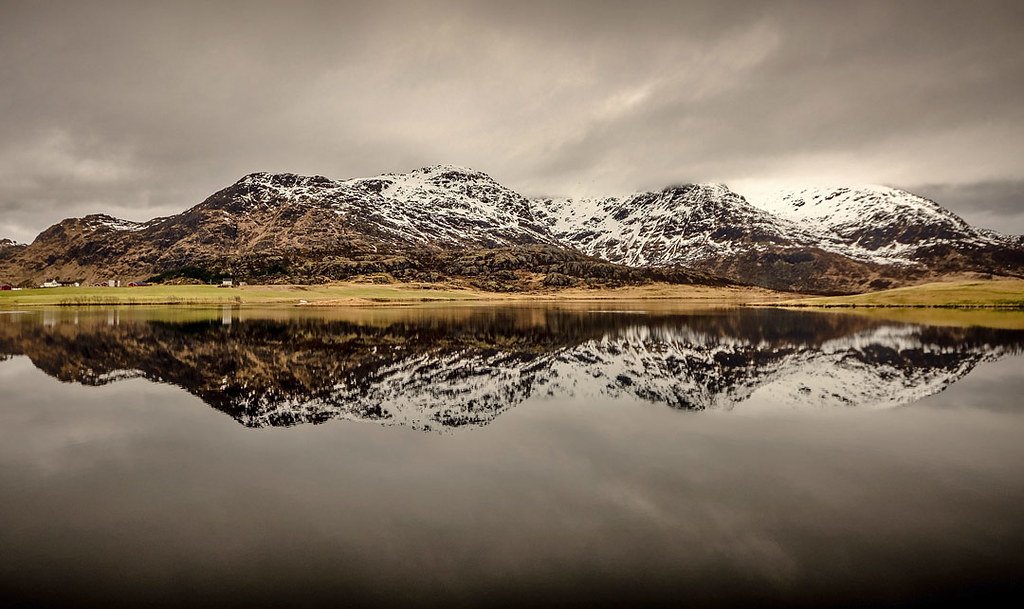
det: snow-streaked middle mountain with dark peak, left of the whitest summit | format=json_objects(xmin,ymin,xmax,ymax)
[{"xmin": 534, "ymin": 184, "xmax": 890, "ymax": 293}]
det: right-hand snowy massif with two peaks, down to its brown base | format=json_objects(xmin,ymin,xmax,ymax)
[{"xmin": 532, "ymin": 184, "xmax": 1024, "ymax": 293}]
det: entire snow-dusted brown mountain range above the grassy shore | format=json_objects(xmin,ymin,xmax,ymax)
[{"xmin": 0, "ymin": 165, "xmax": 1024, "ymax": 294}]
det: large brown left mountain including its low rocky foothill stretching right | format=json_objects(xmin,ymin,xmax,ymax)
[{"xmin": 0, "ymin": 165, "xmax": 725, "ymax": 291}]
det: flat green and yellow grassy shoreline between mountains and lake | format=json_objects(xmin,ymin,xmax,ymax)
[{"xmin": 6, "ymin": 279, "xmax": 1024, "ymax": 311}]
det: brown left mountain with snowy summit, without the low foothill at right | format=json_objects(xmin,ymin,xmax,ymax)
[{"xmin": 9, "ymin": 166, "xmax": 557, "ymax": 279}]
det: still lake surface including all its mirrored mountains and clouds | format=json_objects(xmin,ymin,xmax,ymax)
[{"xmin": 0, "ymin": 306, "xmax": 1024, "ymax": 607}]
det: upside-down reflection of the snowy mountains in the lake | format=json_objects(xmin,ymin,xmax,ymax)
[{"xmin": 0, "ymin": 307, "xmax": 1024, "ymax": 430}]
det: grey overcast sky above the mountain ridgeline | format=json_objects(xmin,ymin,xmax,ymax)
[{"xmin": 0, "ymin": 0, "xmax": 1024, "ymax": 242}]
